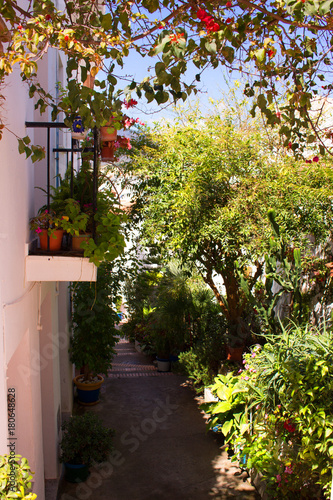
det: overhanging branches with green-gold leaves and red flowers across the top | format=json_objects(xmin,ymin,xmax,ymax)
[{"xmin": 0, "ymin": 0, "xmax": 333, "ymax": 152}]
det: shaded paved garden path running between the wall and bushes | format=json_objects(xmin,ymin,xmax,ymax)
[{"xmin": 58, "ymin": 340, "xmax": 260, "ymax": 500}]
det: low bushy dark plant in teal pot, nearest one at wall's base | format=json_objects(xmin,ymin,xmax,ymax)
[{"xmin": 60, "ymin": 412, "xmax": 114, "ymax": 483}]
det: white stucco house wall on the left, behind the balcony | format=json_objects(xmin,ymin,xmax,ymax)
[{"xmin": 0, "ymin": 41, "xmax": 72, "ymax": 500}]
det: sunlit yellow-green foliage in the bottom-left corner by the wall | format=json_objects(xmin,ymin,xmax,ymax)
[{"xmin": 0, "ymin": 455, "xmax": 37, "ymax": 500}]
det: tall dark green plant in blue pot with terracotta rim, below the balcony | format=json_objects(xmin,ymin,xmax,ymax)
[{"xmin": 70, "ymin": 262, "xmax": 119, "ymax": 405}]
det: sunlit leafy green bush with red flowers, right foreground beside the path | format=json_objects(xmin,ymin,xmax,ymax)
[{"xmin": 204, "ymin": 326, "xmax": 333, "ymax": 499}]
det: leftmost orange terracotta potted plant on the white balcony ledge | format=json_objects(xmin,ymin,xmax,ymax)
[{"xmin": 30, "ymin": 205, "xmax": 64, "ymax": 251}]
